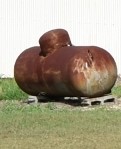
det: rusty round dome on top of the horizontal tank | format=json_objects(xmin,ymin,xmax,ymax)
[{"xmin": 39, "ymin": 29, "xmax": 72, "ymax": 56}]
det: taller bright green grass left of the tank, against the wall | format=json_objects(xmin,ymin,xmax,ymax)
[{"xmin": 0, "ymin": 79, "xmax": 27, "ymax": 100}]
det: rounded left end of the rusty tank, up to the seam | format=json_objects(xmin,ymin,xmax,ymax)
[{"xmin": 14, "ymin": 46, "xmax": 42, "ymax": 96}]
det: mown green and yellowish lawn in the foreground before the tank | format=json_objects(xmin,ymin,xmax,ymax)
[{"xmin": 0, "ymin": 101, "xmax": 121, "ymax": 149}]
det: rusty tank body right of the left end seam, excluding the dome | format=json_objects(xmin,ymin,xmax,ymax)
[{"xmin": 37, "ymin": 46, "xmax": 117, "ymax": 97}]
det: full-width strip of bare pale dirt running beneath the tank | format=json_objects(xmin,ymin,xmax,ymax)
[{"xmin": 0, "ymin": 98, "xmax": 121, "ymax": 111}]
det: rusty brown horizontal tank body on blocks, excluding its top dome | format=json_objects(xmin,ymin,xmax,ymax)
[{"xmin": 14, "ymin": 46, "xmax": 117, "ymax": 97}]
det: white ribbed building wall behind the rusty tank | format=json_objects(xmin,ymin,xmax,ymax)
[{"xmin": 0, "ymin": 0, "xmax": 121, "ymax": 76}]
